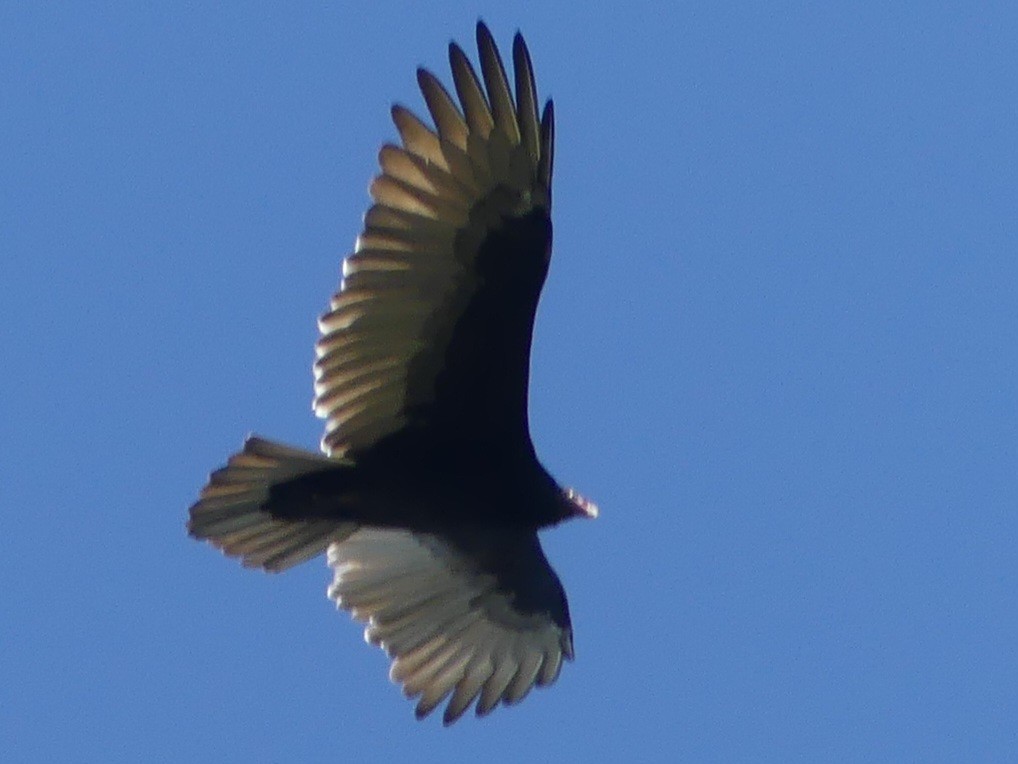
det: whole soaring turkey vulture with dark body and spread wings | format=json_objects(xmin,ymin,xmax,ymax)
[{"xmin": 187, "ymin": 23, "xmax": 598, "ymax": 724}]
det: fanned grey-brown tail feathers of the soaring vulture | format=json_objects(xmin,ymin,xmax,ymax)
[{"xmin": 187, "ymin": 436, "xmax": 357, "ymax": 572}]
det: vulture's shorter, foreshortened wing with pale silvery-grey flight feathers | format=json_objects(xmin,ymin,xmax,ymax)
[{"xmin": 329, "ymin": 529, "xmax": 573, "ymax": 724}]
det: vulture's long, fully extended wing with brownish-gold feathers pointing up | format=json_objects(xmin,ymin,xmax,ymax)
[{"xmin": 315, "ymin": 23, "xmax": 554, "ymax": 454}]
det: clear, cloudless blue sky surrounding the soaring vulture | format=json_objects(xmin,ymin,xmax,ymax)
[{"xmin": 0, "ymin": 2, "xmax": 1018, "ymax": 762}]
